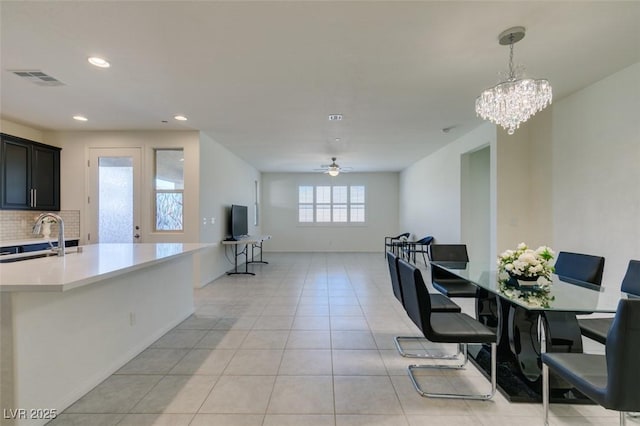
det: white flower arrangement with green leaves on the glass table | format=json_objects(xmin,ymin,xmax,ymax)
[{"xmin": 498, "ymin": 243, "xmax": 555, "ymax": 287}]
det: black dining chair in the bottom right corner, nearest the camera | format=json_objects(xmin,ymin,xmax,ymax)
[{"xmin": 541, "ymin": 299, "xmax": 640, "ymax": 425}]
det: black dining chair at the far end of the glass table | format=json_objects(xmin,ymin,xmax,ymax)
[{"xmin": 430, "ymin": 244, "xmax": 478, "ymax": 297}]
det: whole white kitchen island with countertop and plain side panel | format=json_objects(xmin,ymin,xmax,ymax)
[{"xmin": 0, "ymin": 244, "xmax": 210, "ymax": 425}]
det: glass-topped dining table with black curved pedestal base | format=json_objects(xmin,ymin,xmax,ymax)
[{"xmin": 430, "ymin": 261, "xmax": 633, "ymax": 403}]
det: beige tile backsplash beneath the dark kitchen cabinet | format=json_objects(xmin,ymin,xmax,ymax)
[{"xmin": 0, "ymin": 210, "xmax": 80, "ymax": 241}]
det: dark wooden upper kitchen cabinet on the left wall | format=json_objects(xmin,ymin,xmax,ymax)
[{"xmin": 0, "ymin": 134, "xmax": 60, "ymax": 211}]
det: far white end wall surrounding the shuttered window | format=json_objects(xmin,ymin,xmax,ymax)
[{"xmin": 262, "ymin": 173, "xmax": 399, "ymax": 252}]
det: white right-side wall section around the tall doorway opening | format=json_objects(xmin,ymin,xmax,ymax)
[{"xmin": 400, "ymin": 124, "xmax": 496, "ymax": 253}]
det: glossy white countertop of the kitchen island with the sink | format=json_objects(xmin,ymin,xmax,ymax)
[{"xmin": 0, "ymin": 243, "xmax": 214, "ymax": 292}]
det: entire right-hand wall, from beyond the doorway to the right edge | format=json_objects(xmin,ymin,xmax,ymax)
[{"xmin": 400, "ymin": 64, "xmax": 640, "ymax": 287}]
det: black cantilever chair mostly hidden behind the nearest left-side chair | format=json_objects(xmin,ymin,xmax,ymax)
[{"xmin": 387, "ymin": 252, "xmax": 462, "ymax": 359}]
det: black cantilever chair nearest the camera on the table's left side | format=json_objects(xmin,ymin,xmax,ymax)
[{"xmin": 398, "ymin": 259, "xmax": 497, "ymax": 400}]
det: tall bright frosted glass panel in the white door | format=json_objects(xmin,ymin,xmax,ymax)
[{"xmin": 98, "ymin": 157, "xmax": 134, "ymax": 243}]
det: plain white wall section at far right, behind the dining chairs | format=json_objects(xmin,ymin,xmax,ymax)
[{"xmin": 551, "ymin": 63, "xmax": 640, "ymax": 286}]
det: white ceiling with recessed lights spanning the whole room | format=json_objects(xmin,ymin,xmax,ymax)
[{"xmin": 0, "ymin": 1, "xmax": 640, "ymax": 172}]
